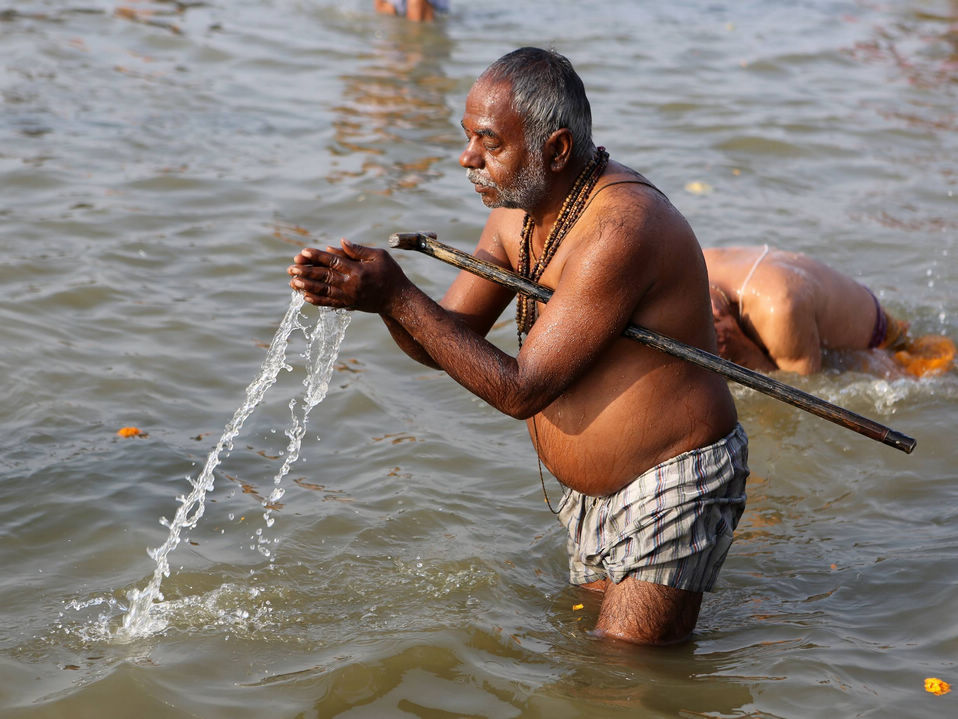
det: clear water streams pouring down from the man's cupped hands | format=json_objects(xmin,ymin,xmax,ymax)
[{"xmin": 116, "ymin": 292, "xmax": 350, "ymax": 641}]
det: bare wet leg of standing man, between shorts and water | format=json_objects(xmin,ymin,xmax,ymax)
[{"xmin": 595, "ymin": 577, "xmax": 702, "ymax": 644}]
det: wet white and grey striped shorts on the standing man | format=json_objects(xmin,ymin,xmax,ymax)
[{"xmin": 558, "ymin": 424, "xmax": 748, "ymax": 592}]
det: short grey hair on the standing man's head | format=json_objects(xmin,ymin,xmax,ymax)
[{"xmin": 479, "ymin": 47, "xmax": 595, "ymax": 165}]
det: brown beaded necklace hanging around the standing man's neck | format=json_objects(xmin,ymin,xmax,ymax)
[{"xmin": 516, "ymin": 147, "xmax": 609, "ymax": 514}]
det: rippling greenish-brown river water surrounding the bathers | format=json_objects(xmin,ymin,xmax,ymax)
[{"xmin": 0, "ymin": 0, "xmax": 958, "ymax": 719}]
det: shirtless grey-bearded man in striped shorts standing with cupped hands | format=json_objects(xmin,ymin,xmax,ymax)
[{"xmin": 289, "ymin": 48, "xmax": 748, "ymax": 644}]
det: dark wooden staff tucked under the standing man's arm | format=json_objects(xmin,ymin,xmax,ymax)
[{"xmin": 389, "ymin": 232, "xmax": 916, "ymax": 454}]
